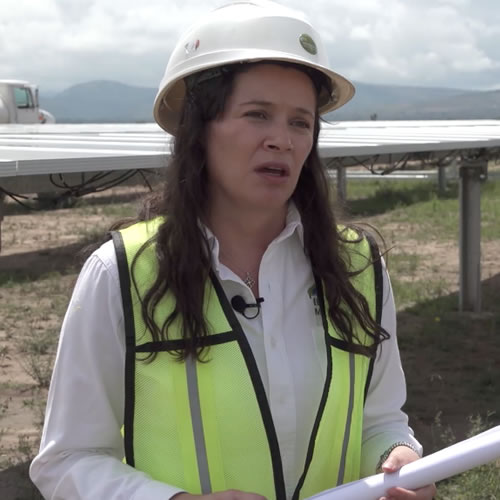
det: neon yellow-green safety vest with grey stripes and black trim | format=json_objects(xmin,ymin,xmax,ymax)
[{"xmin": 113, "ymin": 221, "xmax": 382, "ymax": 500}]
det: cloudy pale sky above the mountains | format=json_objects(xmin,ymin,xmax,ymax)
[{"xmin": 0, "ymin": 0, "xmax": 500, "ymax": 93}]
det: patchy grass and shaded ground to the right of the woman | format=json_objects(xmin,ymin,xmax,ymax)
[{"xmin": 346, "ymin": 176, "xmax": 500, "ymax": 500}]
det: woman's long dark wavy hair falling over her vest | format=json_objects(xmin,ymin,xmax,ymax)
[{"xmin": 118, "ymin": 62, "xmax": 389, "ymax": 360}]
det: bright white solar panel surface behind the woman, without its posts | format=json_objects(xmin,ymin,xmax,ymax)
[{"xmin": 0, "ymin": 120, "xmax": 500, "ymax": 177}]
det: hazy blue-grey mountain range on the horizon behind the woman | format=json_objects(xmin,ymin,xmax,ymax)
[{"xmin": 40, "ymin": 80, "xmax": 500, "ymax": 123}]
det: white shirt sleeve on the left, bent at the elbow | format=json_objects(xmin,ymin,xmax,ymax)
[{"xmin": 30, "ymin": 242, "xmax": 182, "ymax": 500}]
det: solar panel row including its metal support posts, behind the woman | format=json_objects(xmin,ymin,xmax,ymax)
[{"xmin": 0, "ymin": 120, "xmax": 500, "ymax": 311}]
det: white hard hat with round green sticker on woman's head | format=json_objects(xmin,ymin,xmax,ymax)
[{"xmin": 153, "ymin": 1, "xmax": 354, "ymax": 135}]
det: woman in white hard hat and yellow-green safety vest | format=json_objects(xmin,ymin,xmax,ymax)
[{"xmin": 31, "ymin": 2, "xmax": 434, "ymax": 500}]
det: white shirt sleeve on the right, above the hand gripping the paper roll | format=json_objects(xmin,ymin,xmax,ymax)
[{"xmin": 361, "ymin": 262, "xmax": 422, "ymax": 477}]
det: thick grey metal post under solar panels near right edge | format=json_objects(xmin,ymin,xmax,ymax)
[{"xmin": 459, "ymin": 162, "xmax": 487, "ymax": 312}]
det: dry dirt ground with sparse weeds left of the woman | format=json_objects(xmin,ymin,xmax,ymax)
[{"xmin": 0, "ymin": 187, "xmax": 145, "ymax": 454}]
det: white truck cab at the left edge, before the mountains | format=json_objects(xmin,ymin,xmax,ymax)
[{"xmin": 0, "ymin": 80, "xmax": 56, "ymax": 124}]
